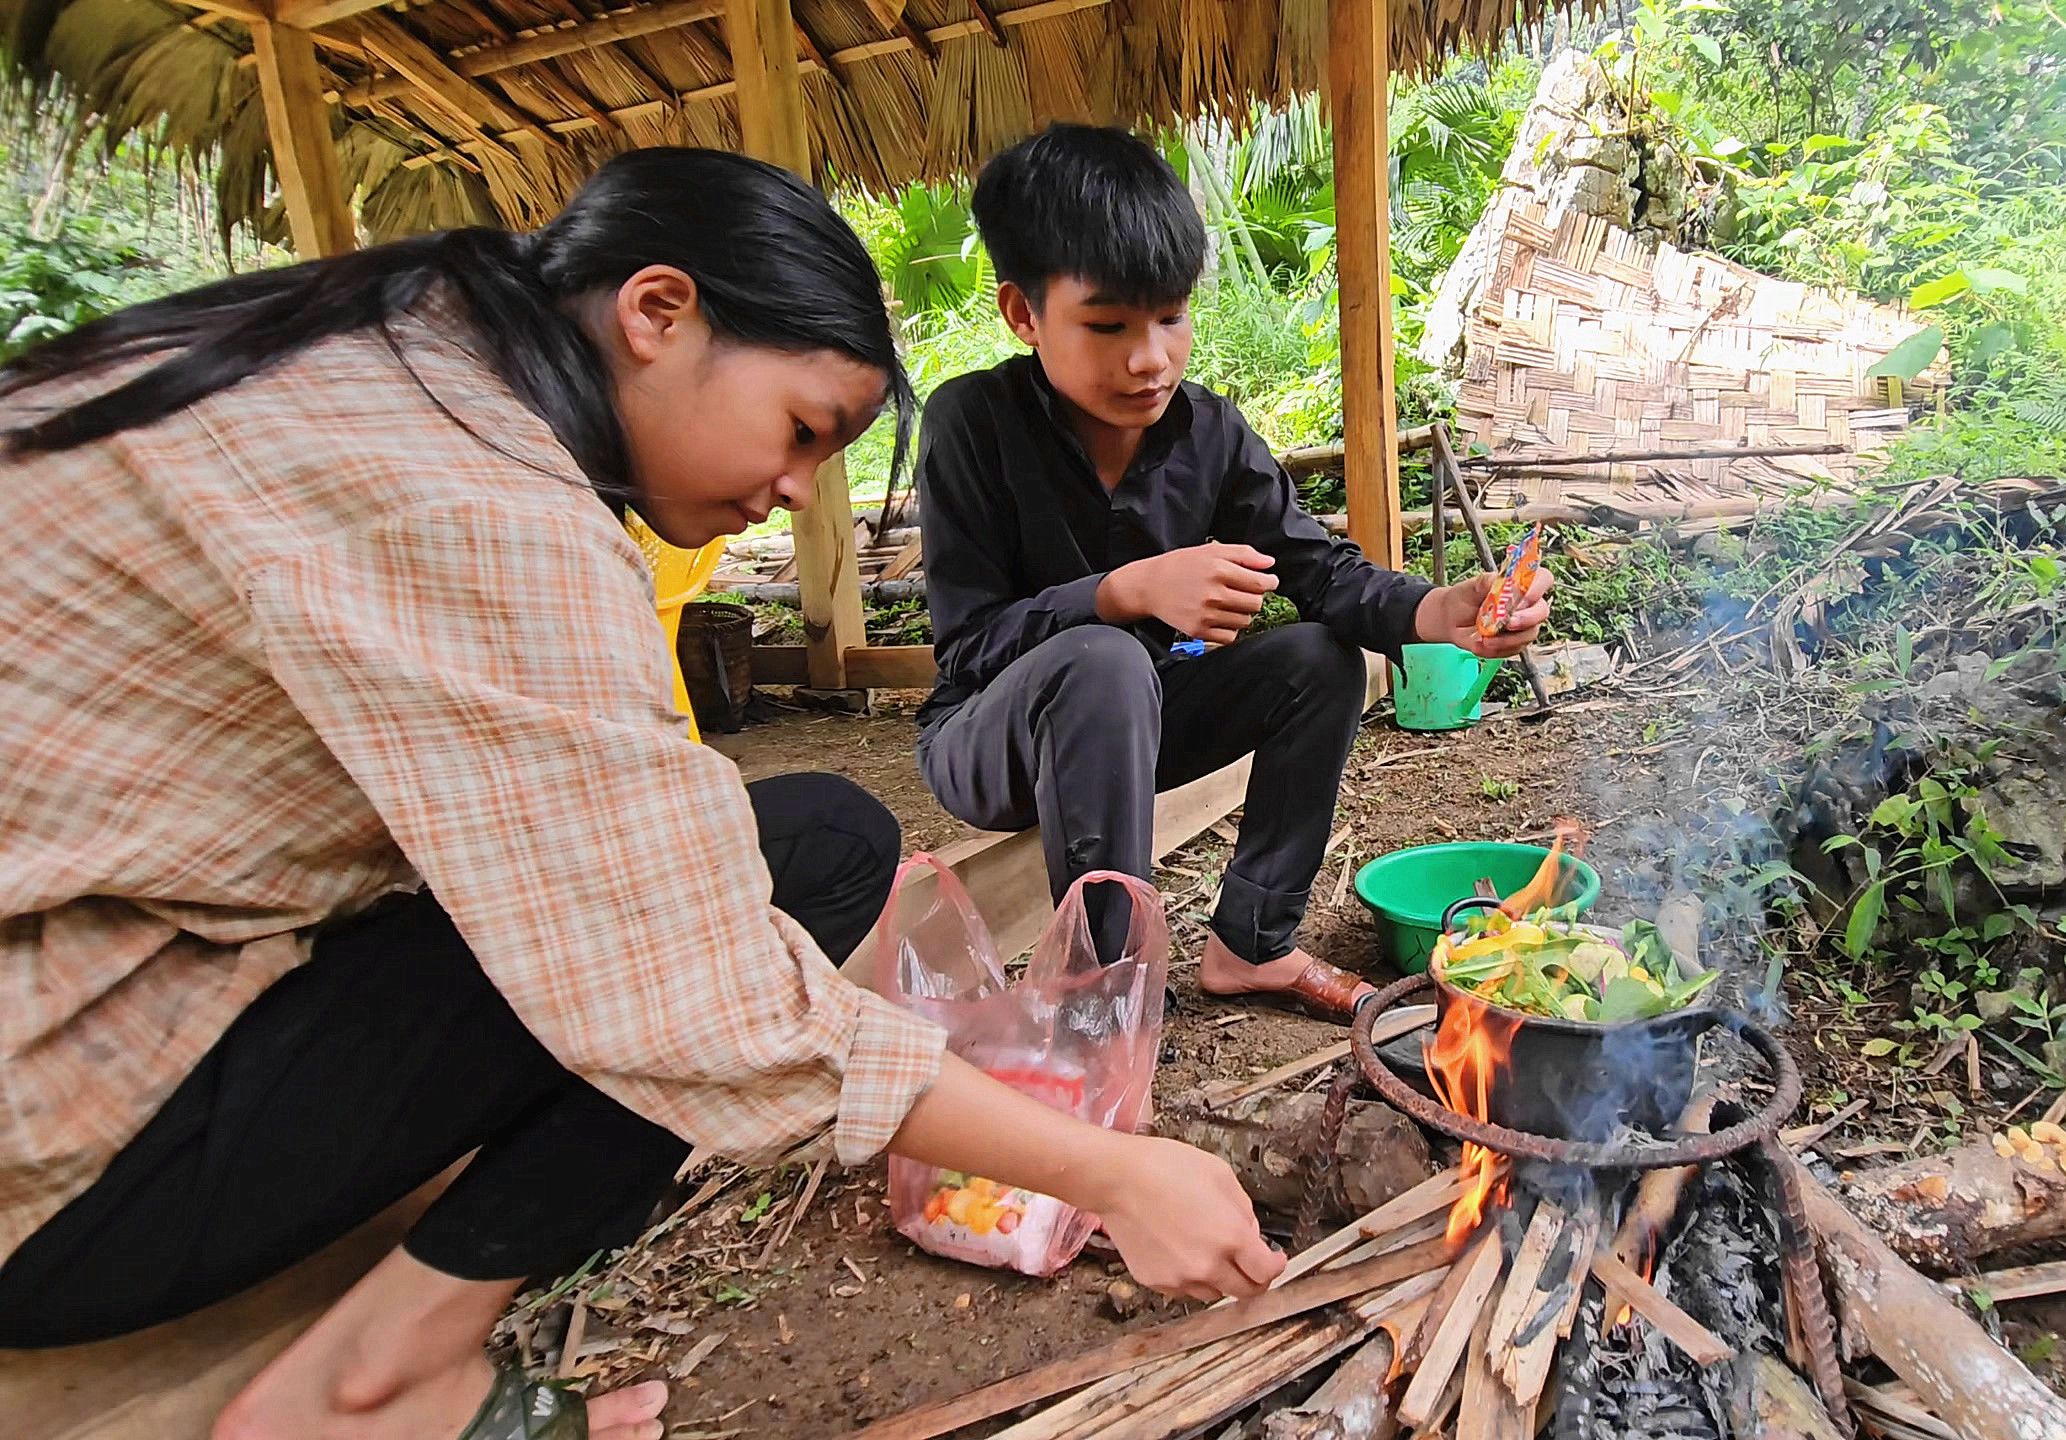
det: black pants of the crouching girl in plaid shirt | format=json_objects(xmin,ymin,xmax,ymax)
[{"xmin": 0, "ymin": 775, "xmax": 899, "ymax": 1347}]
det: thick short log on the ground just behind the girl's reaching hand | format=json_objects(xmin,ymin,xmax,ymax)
[{"xmin": 1155, "ymin": 1091, "xmax": 1434, "ymax": 1225}]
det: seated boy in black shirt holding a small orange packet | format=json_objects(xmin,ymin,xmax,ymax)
[{"xmin": 917, "ymin": 126, "xmax": 1550, "ymax": 1014}]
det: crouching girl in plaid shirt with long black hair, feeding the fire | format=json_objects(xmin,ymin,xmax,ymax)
[{"xmin": 0, "ymin": 149, "xmax": 1283, "ymax": 1440}]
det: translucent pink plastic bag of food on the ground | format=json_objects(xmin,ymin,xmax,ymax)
[{"xmin": 857, "ymin": 855, "xmax": 1169, "ymax": 1275}]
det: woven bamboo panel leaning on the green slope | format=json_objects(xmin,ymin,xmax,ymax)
[{"xmin": 1457, "ymin": 202, "xmax": 1936, "ymax": 504}]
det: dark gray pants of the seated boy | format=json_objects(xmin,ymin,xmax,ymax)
[{"xmin": 917, "ymin": 624, "xmax": 1364, "ymax": 961}]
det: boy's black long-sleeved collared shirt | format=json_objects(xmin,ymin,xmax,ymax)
[{"xmin": 917, "ymin": 355, "xmax": 1430, "ymax": 727}]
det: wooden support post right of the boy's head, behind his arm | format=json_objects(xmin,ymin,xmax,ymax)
[{"xmin": 1326, "ymin": 0, "xmax": 1405, "ymax": 570}]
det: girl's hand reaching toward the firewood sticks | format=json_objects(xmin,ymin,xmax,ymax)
[{"xmin": 1087, "ymin": 1134, "xmax": 1285, "ymax": 1302}]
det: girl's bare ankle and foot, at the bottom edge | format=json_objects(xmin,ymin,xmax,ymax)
[{"xmin": 213, "ymin": 1250, "xmax": 667, "ymax": 1440}]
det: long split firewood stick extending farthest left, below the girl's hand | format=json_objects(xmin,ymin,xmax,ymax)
[{"xmin": 853, "ymin": 1242, "xmax": 1448, "ymax": 1440}]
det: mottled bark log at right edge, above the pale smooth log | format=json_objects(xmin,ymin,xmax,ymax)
[{"xmin": 1843, "ymin": 1142, "xmax": 2066, "ymax": 1275}]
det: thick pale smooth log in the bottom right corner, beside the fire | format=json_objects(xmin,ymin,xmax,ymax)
[{"xmin": 1787, "ymin": 1161, "xmax": 2066, "ymax": 1440}]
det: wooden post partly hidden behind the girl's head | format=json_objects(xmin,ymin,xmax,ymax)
[{"xmin": 725, "ymin": 0, "xmax": 868, "ymax": 690}]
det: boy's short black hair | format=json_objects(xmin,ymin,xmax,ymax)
[{"xmin": 975, "ymin": 124, "xmax": 1204, "ymax": 308}]
